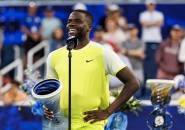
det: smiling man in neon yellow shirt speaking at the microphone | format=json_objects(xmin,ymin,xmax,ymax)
[{"xmin": 45, "ymin": 10, "xmax": 139, "ymax": 130}]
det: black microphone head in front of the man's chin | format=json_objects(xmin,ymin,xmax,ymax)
[{"xmin": 67, "ymin": 36, "xmax": 78, "ymax": 50}]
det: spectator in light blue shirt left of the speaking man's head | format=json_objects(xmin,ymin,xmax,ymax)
[{"xmin": 41, "ymin": 6, "xmax": 62, "ymax": 40}]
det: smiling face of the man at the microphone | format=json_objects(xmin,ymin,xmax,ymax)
[{"xmin": 67, "ymin": 12, "xmax": 90, "ymax": 39}]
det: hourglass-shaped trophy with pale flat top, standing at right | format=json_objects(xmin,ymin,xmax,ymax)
[{"xmin": 146, "ymin": 79, "xmax": 174, "ymax": 130}]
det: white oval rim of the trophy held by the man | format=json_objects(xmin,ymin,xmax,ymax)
[{"xmin": 31, "ymin": 79, "xmax": 62, "ymax": 99}]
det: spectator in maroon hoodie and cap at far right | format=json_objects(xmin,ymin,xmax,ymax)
[{"xmin": 156, "ymin": 25, "xmax": 183, "ymax": 79}]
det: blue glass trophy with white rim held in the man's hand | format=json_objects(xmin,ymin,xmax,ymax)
[{"xmin": 31, "ymin": 79, "xmax": 68, "ymax": 130}]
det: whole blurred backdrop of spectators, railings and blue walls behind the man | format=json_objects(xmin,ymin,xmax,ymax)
[{"xmin": 0, "ymin": 0, "xmax": 185, "ymax": 130}]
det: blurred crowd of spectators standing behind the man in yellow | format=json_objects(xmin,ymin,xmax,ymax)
[{"xmin": 0, "ymin": 0, "xmax": 185, "ymax": 104}]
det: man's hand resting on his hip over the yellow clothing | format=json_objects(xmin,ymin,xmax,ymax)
[{"xmin": 84, "ymin": 110, "xmax": 110, "ymax": 124}]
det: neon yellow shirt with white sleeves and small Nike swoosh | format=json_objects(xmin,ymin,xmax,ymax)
[{"xmin": 47, "ymin": 41, "xmax": 125, "ymax": 130}]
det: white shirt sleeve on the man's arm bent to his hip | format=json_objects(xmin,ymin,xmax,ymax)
[{"xmin": 104, "ymin": 48, "xmax": 126, "ymax": 76}]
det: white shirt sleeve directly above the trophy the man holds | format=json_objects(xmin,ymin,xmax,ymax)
[{"xmin": 46, "ymin": 53, "xmax": 58, "ymax": 79}]
